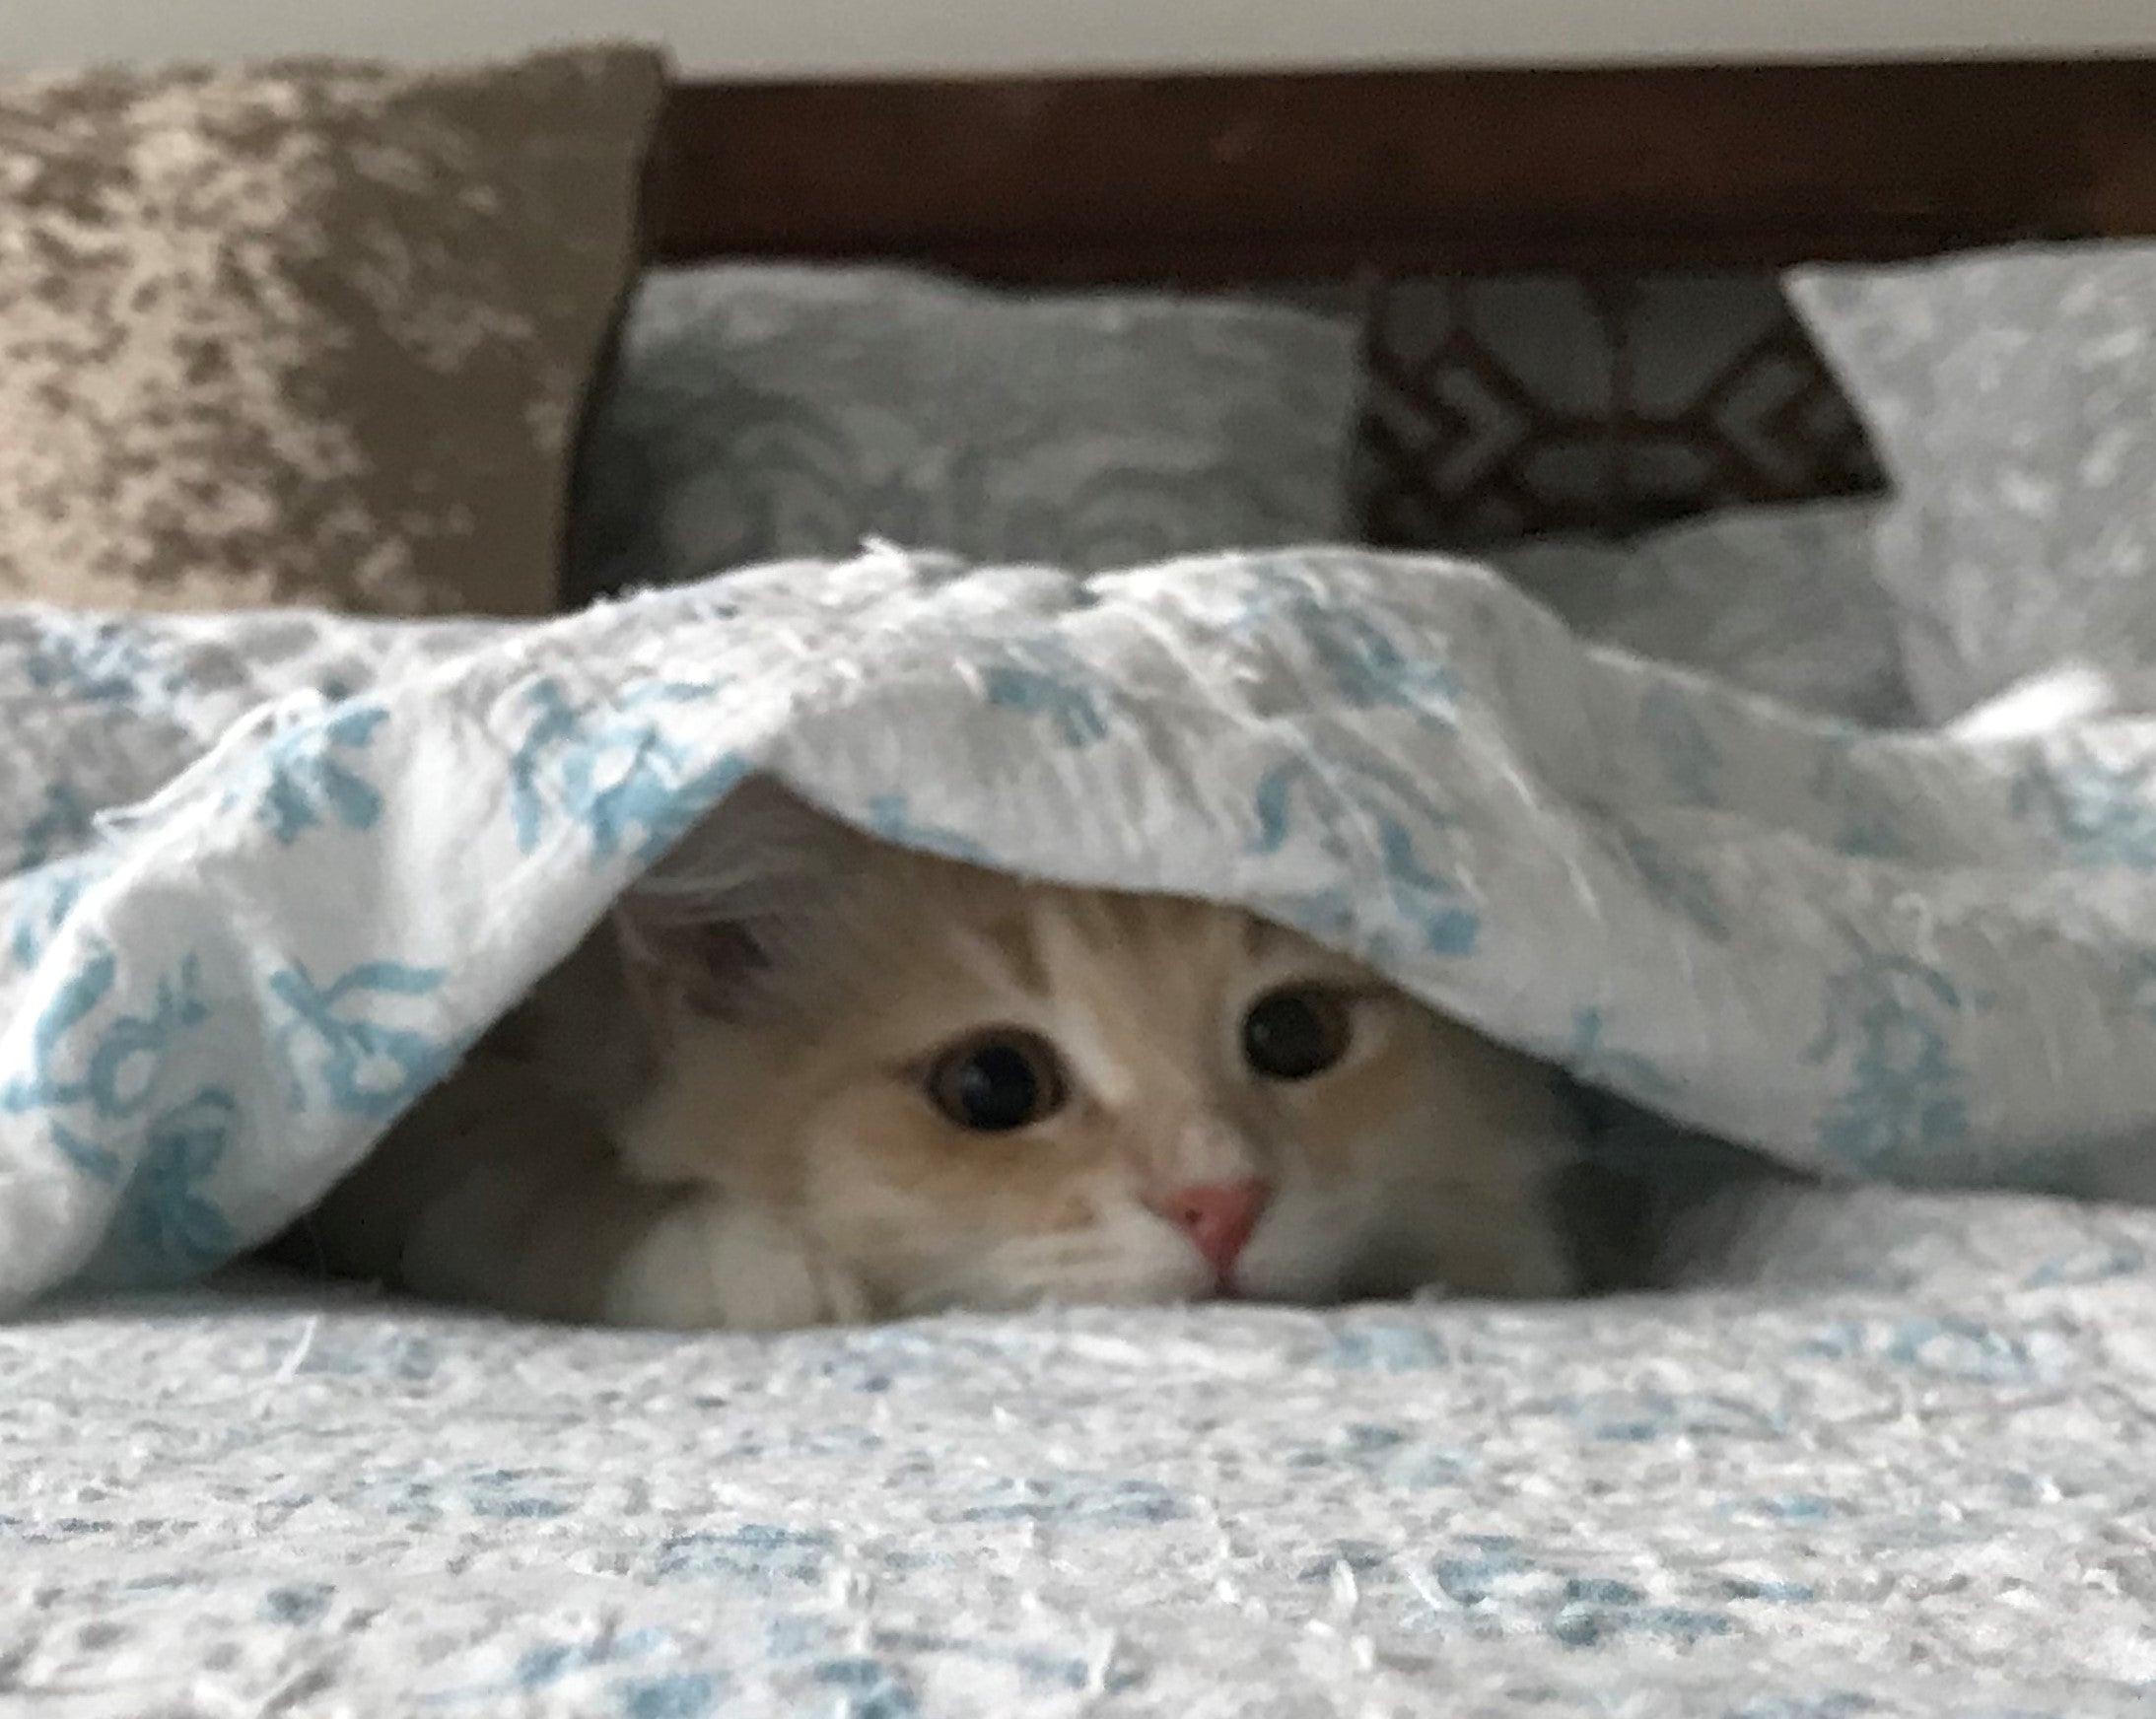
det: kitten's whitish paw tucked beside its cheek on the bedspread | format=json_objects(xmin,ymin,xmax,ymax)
[{"xmin": 599, "ymin": 1197, "xmax": 869, "ymax": 1331}]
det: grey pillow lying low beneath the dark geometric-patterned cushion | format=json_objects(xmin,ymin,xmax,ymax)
[{"xmin": 1490, "ymin": 501, "xmax": 1914, "ymax": 726}]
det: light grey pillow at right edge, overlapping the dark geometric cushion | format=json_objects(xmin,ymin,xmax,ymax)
[{"xmin": 1789, "ymin": 243, "xmax": 2156, "ymax": 722}]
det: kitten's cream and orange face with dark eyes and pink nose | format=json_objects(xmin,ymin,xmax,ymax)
[{"xmin": 623, "ymin": 789, "xmax": 1567, "ymax": 1314}]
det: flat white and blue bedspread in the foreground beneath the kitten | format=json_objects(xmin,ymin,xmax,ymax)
[{"xmin": 0, "ymin": 1193, "xmax": 2156, "ymax": 1719}]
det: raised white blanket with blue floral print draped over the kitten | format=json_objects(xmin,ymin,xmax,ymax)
[{"xmin": 0, "ymin": 550, "xmax": 2156, "ymax": 1305}]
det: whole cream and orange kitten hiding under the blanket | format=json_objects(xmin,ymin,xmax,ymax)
[{"xmin": 299, "ymin": 783, "xmax": 1569, "ymax": 1331}]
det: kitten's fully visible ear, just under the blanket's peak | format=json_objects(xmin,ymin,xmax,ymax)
[{"xmin": 614, "ymin": 777, "xmax": 867, "ymax": 1018}]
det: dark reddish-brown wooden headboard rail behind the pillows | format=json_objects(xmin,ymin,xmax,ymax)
[{"xmin": 656, "ymin": 58, "xmax": 2156, "ymax": 285}]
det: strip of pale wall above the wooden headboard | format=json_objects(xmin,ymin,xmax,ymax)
[{"xmin": 12, "ymin": 0, "xmax": 2156, "ymax": 76}]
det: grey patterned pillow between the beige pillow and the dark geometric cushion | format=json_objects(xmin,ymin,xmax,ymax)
[{"xmin": 574, "ymin": 263, "xmax": 1358, "ymax": 591}]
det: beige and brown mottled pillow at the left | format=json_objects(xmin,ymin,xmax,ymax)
[{"xmin": 0, "ymin": 49, "xmax": 664, "ymax": 615}]
